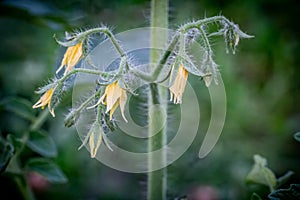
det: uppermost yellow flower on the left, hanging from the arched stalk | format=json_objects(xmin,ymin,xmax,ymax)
[{"xmin": 56, "ymin": 42, "xmax": 82, "ymax": 75}]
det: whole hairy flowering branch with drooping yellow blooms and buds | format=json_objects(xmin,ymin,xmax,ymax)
[{"xmin": 32, "ymin": 16, "xmax": 252, "ymax": 158}]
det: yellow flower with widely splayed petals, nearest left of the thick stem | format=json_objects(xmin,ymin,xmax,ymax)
[{"xmin": 89, "ymin": 81, "xmax": 127, "ymax": 122}]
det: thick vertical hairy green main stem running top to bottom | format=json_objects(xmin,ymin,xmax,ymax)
[{"xmin": 147, "ymin": 0, "xmax": 168, "ymax": 200}]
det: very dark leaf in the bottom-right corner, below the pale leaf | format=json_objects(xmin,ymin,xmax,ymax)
[{"xmin": 268, "ymin": 184, "xmax": 300, "ymax": 200}]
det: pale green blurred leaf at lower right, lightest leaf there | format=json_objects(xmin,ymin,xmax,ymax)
[{"xmin": 246, "ymin": 155, "xmax": 276, "ymax": 191}]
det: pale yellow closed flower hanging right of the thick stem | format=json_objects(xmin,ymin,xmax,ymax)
[{"xmin": 169, "ymin": 64, "xmax": 189, "ymax": 104}]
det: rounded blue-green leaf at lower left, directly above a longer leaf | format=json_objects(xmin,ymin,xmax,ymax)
[{"xmin": 26, "ymin": 131, "xmax": 57, "ymax": 157}]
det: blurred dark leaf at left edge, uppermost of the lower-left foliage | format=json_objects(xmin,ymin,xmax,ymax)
[{"xmin": 0, "ymin": 97, "xmax": 35, "ymax": 121}]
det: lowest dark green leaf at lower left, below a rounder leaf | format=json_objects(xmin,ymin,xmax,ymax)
[{"xmin": 25, "ymin": 158, "xmax": 68, "ymax": 183}]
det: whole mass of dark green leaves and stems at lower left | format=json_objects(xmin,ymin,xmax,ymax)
[{"xmin": 0, "ymin": 97, "xmax": 67, "ymax": 199}]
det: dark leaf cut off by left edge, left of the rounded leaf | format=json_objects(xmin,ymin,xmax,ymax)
[{"xmin": 0, "ymin": 137, "xmax": 14, "ymax": 174}]
